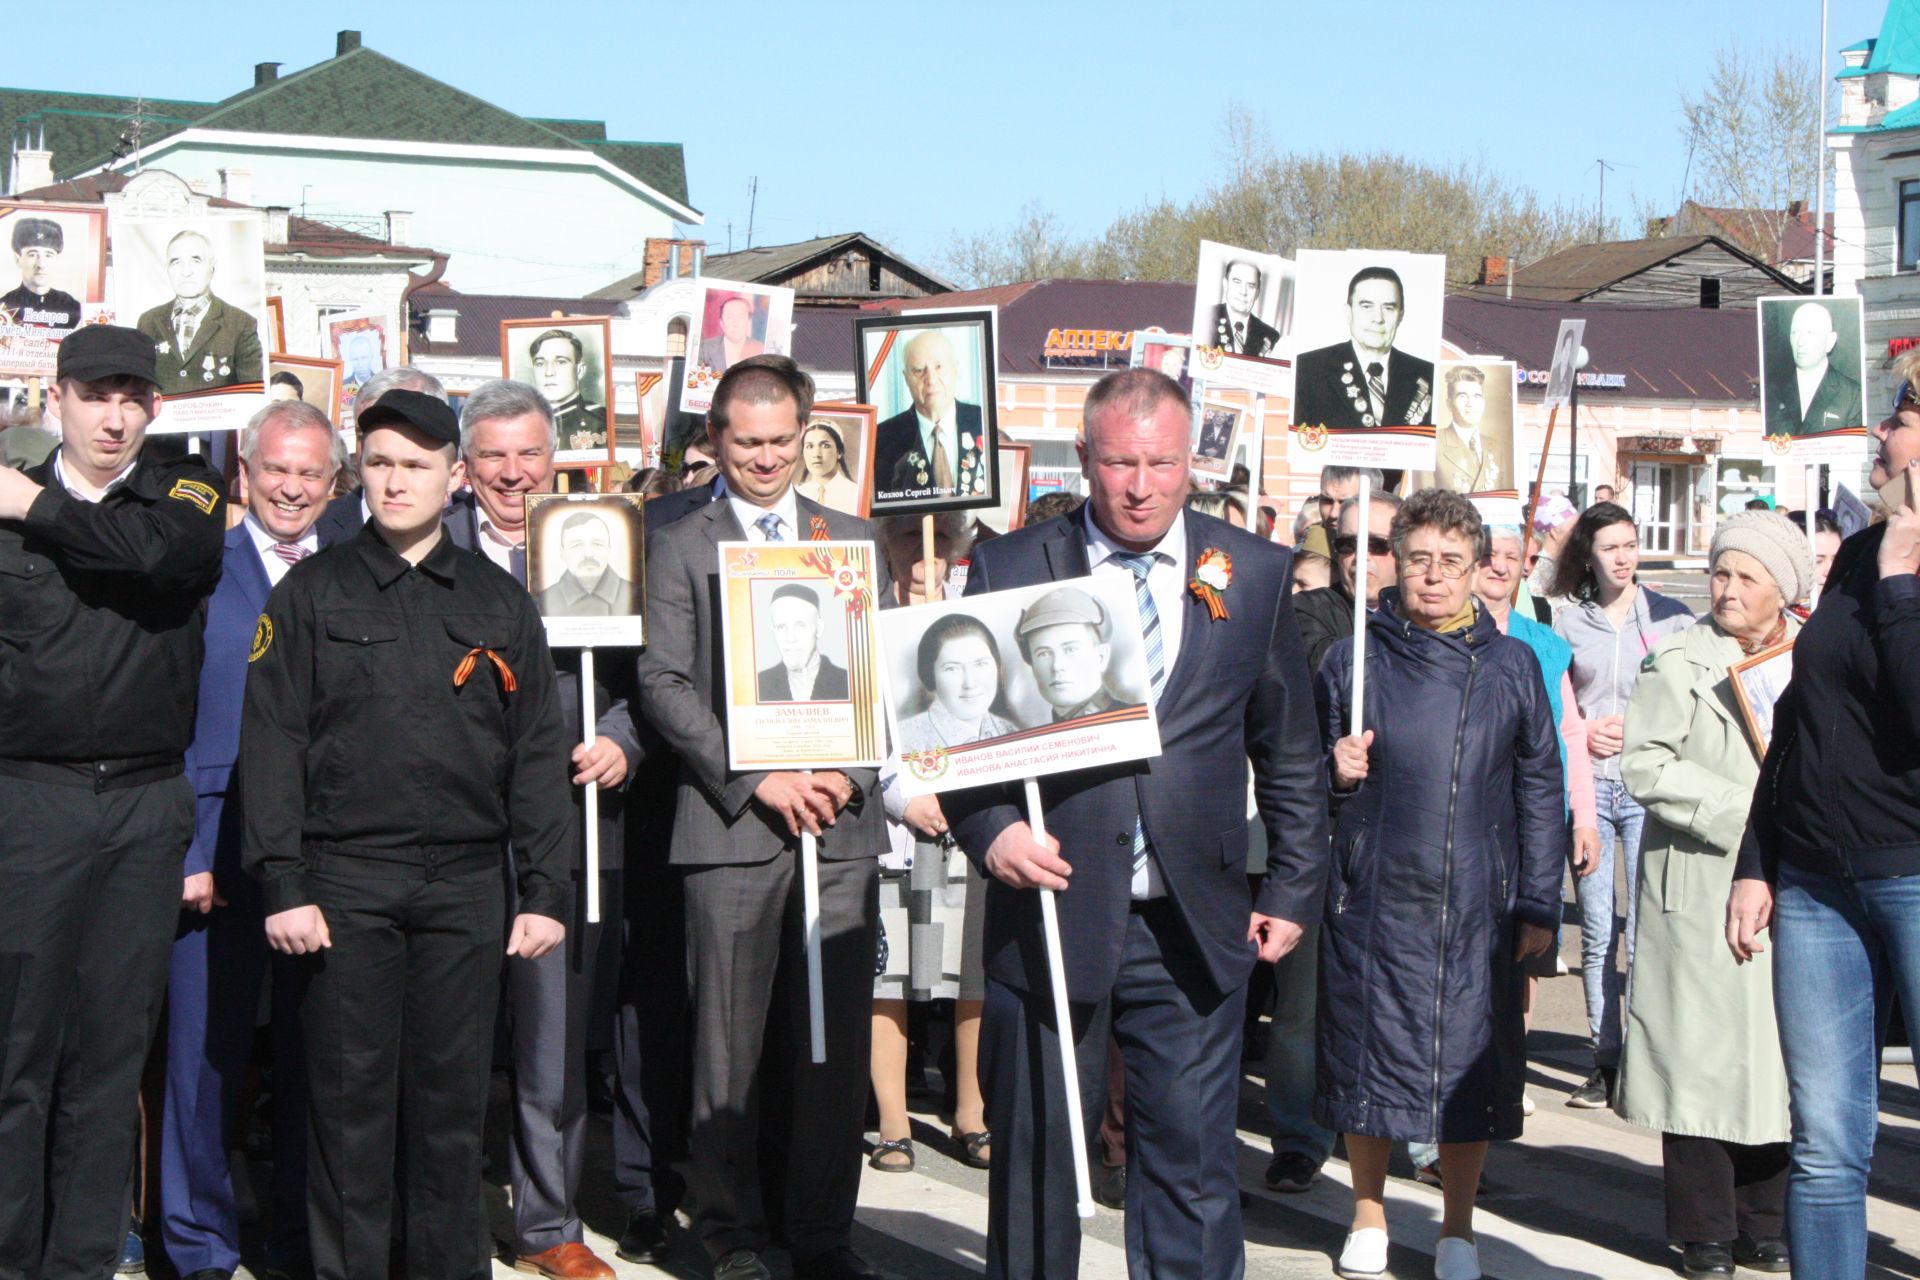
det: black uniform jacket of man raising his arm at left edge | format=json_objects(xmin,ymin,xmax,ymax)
[{"xmin": 0, "ymin": 453, "xmax": 227, "ymax": 789}]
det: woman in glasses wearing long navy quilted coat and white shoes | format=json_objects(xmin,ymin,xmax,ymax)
[{"xmin": 1313, "ymin": 489, "xmax": 1567, "ymax": 1280}]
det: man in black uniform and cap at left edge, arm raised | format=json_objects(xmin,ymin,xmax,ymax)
[{"xmin": 0, "ymin": 324, "xmax": 227, "ymax": 1276}]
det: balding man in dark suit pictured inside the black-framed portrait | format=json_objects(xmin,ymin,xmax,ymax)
[{"xmin": 874, "ymin": 328, "xmax": 987, "ymax": 503}]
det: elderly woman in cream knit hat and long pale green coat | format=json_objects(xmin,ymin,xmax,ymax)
[{"xmin": 1615, "ymin": 510, "xmax": 1812, "ymax": 1276}]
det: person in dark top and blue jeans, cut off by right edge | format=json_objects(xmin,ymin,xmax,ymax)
[{"xmin": 1726, "ymin": 351, "xmax": 1920, "ymax": 1276}]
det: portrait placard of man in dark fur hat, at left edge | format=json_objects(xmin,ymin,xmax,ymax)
[{"xmin": 0, "ymin": 200, "xmax": 108, "ymax": 378}]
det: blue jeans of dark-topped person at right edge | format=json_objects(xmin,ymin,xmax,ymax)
[{"xmin": 1770, "ymin": 864, "xmax": 1920, "ymax": 1276}]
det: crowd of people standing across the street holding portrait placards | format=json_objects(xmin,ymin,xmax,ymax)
[{"xmin": 0, "ymin": 326, "xmax": 1920, "ymax": 1280}]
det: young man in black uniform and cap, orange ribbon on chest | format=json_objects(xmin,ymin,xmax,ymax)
[{"xmin": 240, "ymin": 391, "xmax": 572, "ymax": 1280}]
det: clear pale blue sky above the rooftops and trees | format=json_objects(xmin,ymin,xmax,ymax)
[{"xmin": 0, "ymin": 0, "xmax": 1889, "ymax": 280}]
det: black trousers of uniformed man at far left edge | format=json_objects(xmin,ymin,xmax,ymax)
[{"xmin": 0, "ymin": 777, "xmax": 194, "ymax": 1280}]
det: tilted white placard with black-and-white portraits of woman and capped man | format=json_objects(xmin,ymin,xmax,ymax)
[{"xmin": 879, "ymin": 574, "xmax": 1160, "ymax": 796}]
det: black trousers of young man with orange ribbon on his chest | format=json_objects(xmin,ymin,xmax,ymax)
[{"xmin": 301, "ymin": 858, "xmax": 520, "ymax": 1280}]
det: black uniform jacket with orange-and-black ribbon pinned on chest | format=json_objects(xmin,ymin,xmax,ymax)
[{"xmin": 238, "ymin": 524, "xmax": 572, "ymax": 921}]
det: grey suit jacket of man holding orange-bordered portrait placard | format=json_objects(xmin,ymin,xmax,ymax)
[{"xmin": 639, "ymin": 497, "xmax": 889, "ymax": 865}]
